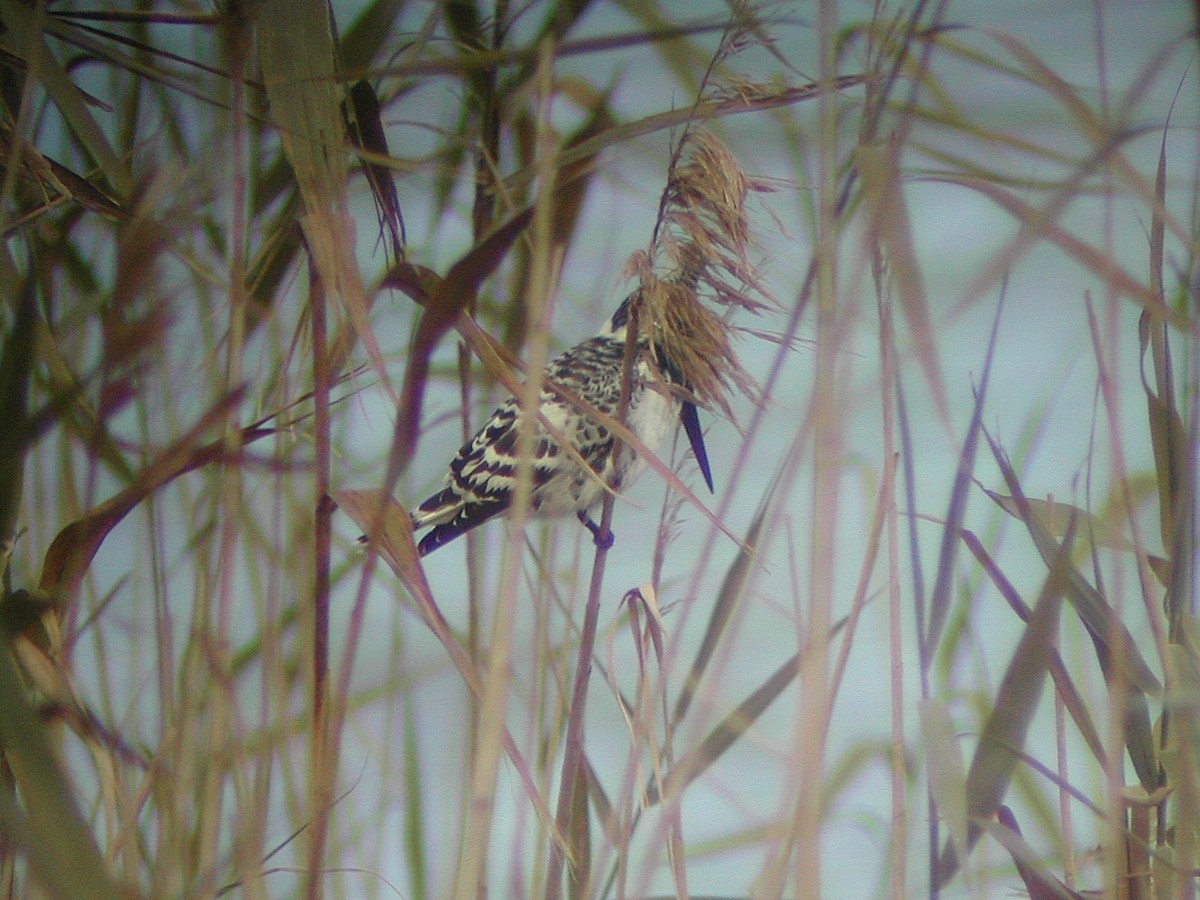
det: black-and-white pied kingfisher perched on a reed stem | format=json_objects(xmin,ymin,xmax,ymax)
[{"xmin": 412, "ymin": 292, "xmax": 713, "ymax": 556}]
